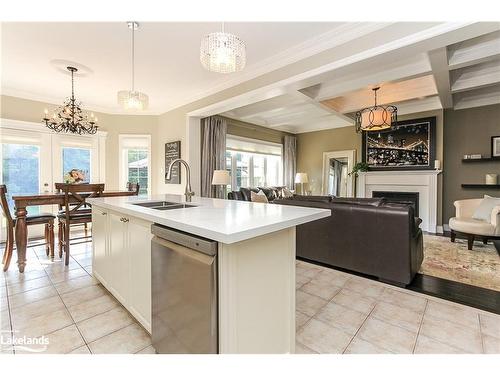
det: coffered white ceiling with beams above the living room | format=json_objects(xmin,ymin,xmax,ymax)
[{"xmin": 223, "ymin": 23, "xmax": 500, "ymax": 133}]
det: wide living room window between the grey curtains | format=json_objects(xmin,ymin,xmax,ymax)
[{"xmin": 226, "ymin": 136, "xmax": 283, "ymax": 190}]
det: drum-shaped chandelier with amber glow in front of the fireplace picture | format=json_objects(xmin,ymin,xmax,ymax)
[{"xmin": 356, "ymin": 87, "xmax": 398, "ymax": 132}]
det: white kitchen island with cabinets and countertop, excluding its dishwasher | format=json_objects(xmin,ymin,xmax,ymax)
[{"xmin": 88, "ymin": 195, "xmax": 330, "ymax": 353}]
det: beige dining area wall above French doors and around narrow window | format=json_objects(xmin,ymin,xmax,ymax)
[{"xmin": 0, "ymin": 95, "xmax": 158, "ymax": 189}]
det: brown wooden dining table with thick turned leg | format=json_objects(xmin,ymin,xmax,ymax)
[{"xmin": 12, "ymin": 190, "xmax": 137, "ymax": 273}]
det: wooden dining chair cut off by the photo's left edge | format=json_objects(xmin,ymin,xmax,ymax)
[{"xmin": 0, "ymin": 185, "xmax": 56, "ymax": 272}]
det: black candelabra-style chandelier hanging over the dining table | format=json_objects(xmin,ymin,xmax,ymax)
[{"xmin": 42, "ymin": 66, "xmax": 99, "ymax": 135}]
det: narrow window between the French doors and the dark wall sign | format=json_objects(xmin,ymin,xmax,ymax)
[{"xmin": 119, "ymin": 134, "xmax": 151, "ymax": 196}]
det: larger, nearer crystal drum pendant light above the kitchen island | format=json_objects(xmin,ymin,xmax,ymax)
[{"xmin": 200, "ymin": 23, "xmax": 246, "ymax": 73}]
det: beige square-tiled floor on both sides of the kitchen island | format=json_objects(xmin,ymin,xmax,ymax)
[{"xmin": 0, "ymin": 239, "xmax": 500, "ymax": 354}]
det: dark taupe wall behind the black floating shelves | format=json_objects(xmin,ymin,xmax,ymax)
[{"xmin": 443, "ymin": 104, "xmax": 500, "ymax": 224}]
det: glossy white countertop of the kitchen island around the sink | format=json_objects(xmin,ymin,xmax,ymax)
[{"xmin": 87, "ymin": 194, "xmax": 331, "ymax": 244}]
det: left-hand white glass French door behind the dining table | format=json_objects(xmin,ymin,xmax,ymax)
[{"xmin": 0, "ymin": 129, "xmax": 52, "ymax": 241}]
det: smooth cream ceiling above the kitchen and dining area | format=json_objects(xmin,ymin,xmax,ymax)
[{"xmin": 1, "ymin": 22, "xmax": 347, "ymax": 114}]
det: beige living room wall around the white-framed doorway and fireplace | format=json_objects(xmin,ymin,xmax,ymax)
[{"xmin": 297, "ymin": 110, "xmax": 443, "ymax": 225}]
